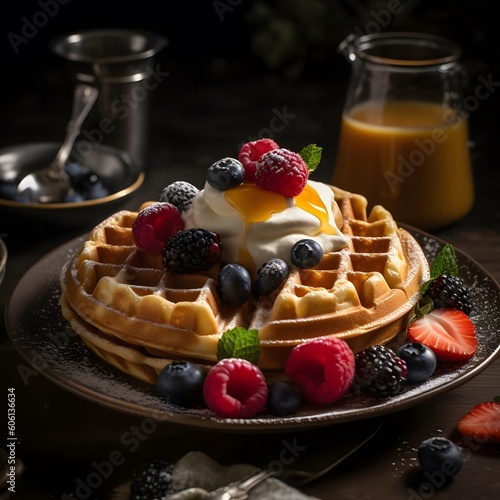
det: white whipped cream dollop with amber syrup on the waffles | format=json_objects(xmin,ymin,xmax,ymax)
[{"xmin": 182, "ymin": 180, "xmax": 347, "ymax": 272}]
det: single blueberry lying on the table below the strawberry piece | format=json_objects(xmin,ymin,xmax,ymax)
[{"xmin": 417, "ymin": 437, "xmax": 463, "ymax": 478}]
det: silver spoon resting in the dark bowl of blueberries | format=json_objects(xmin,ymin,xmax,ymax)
[{"xmin": 17, "ymin": 85, "xmax": 99, "ymax": 203}]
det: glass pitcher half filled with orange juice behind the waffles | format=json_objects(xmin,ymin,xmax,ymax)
[{"xmin": 333, "ymin": 33, "xmax": 474, "ymax": 230}]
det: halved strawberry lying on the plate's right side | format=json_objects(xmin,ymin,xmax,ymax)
[{"xmin": 408, "ymin": 308, "xmax": 477, "ymax": 363}]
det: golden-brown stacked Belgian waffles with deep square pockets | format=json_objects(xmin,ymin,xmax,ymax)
[{"xmin": 61, "ymin": 188, "xmax": 428, "ymax": 383}]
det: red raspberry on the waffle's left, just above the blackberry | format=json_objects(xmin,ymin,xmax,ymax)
[{"xmin": 132, "ymin": 202, "xmax": 184, "ymax": 255}]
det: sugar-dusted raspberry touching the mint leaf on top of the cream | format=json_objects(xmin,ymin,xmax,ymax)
[{"xmin": 255, "ymin": 149, "xmax": 309, "ymax": 198}]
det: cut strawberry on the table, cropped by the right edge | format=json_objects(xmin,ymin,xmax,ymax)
[{"xmin": 457, "ymin": 401, "xmax": 500, "ymax": 444}]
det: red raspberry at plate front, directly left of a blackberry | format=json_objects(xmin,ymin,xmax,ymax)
[{"xmin": 285, "ymin": 337, "xmax": 354, "ymax": 404}]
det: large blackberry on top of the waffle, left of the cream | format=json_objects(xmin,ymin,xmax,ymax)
[{"xmin": 163, "ymin": 228, "xmax": 222, "ymax": 274}]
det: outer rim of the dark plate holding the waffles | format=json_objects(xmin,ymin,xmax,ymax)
[{"xmin": 4, "ymin": 223, "xmax": 500, "ymax": 432}]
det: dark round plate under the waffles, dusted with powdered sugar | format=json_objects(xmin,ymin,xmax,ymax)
[{"xmin": 6, "ymin": 228, "xmax": 500, "ymax": 432}]
